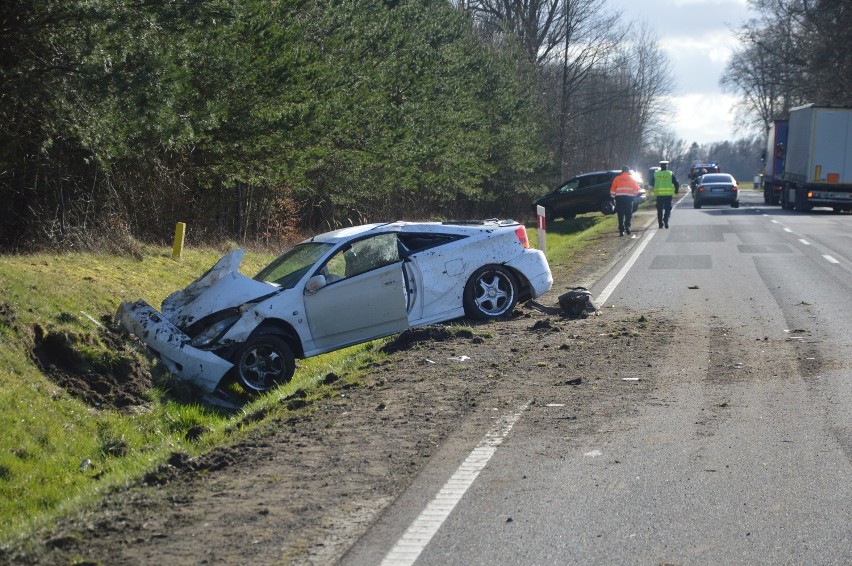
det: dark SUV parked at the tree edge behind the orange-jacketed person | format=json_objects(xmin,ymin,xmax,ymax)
[{"xmin": 533, "ymin": 169, "xmax": 646, "ymax": 219}]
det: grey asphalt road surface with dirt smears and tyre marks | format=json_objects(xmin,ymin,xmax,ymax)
[{"xmin": 346, "ymin": 193, "xmax": 852, "ymax": 566}]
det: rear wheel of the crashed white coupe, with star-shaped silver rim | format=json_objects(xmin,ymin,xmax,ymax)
[{"xmin": 462, "ymin": 265, "xmax": 519, "ymax": 320}]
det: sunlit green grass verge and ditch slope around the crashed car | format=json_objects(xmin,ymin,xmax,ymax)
[{"xmin": 0, "ymin": 214, "xmax": 615, "ymax": 546}]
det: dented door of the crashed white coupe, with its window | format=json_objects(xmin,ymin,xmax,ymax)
[{"xmin": 304, "ymin": 233, "xmax": 408, "ymax": 351}]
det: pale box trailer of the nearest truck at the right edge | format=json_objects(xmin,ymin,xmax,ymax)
[{"xmin": 781, "ymin": 104, "xmax": 852, "ymax": 212}]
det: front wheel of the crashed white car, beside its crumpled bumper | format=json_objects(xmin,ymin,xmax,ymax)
[{"xmin": 232, "ymin": 334, "xmax": 296, "ymax": 393}]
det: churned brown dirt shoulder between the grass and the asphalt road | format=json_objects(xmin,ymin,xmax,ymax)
[{"xmin": 0, "ymin": 219, "xmax": 676, "ymax": 565}]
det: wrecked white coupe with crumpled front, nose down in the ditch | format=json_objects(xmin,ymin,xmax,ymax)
[{"xmin": 116, "ymin": 220, "xmax": 553, "ymax": 392}]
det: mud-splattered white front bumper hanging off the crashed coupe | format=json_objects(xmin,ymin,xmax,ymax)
[{"xmin": 115, "ymin": 300, "xmax": 234, "ymax": 392}]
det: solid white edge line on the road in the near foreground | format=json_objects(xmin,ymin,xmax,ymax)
[{"xmin": 382, "ymin": 401, "xmax": 530, "ymax": 566}]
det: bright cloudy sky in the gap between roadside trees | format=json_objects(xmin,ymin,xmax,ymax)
[{"xmin": 609, "ymin": 0, "xmax": 753, "ymax": 144}]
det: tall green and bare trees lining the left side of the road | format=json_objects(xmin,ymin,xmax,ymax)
[{"xmin": 0, "ymin": 0, "xmax": 673, "ymax": 251}]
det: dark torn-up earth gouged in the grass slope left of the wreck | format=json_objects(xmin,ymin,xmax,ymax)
[{"xmin": 32, "ymin": 324, "xmax": 153, "ymax": 410}]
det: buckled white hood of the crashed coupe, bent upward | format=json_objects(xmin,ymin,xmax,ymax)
[{"xmin": 162, "ymin": 250, "xmax": 278, "ymax": 328}]
